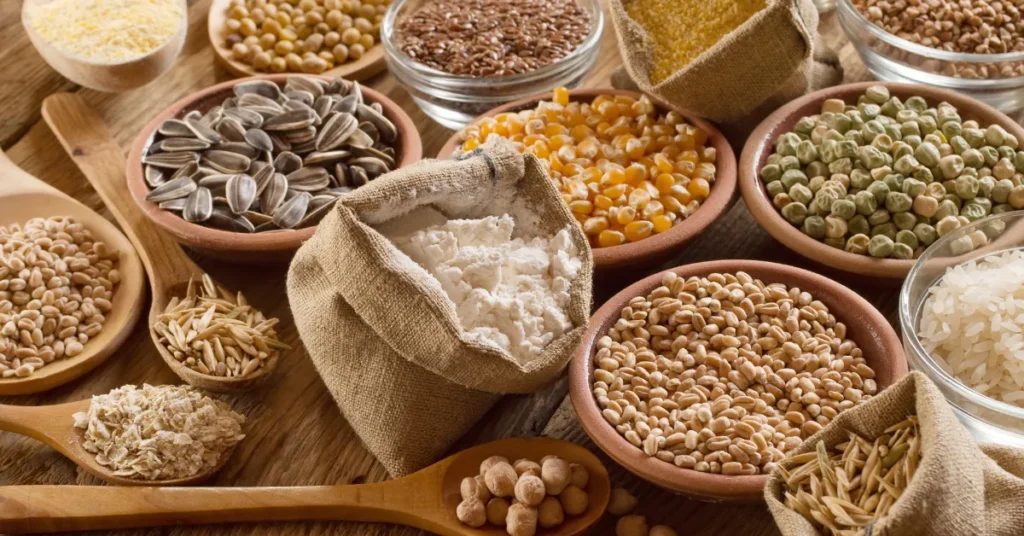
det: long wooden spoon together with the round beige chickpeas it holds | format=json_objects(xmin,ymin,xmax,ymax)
[{"xmin": 0, "ymin": 438, "xmax": 611, "ymax": 536}]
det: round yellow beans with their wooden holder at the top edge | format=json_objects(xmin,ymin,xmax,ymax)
[{"xmin": 207, "ymin": 0, "xmax": 391, "ymax": 80}]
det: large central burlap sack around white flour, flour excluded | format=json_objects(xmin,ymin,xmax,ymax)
[{"xmin": 288, "ymin": 140, "xmax": 593, "ymax": 477}]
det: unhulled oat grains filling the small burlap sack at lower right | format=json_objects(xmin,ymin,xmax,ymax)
[{"xmin": 779, "ymin": 415, "xmax": 921, "ymax": 536}]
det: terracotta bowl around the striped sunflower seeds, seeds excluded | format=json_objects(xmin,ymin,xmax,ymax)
[{"xmin": 126, "ymin": 75, "xmax": 423, "ymax": 262}]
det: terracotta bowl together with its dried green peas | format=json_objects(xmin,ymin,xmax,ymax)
[{"xmin": 739, "ymin": 82, "xmax": 1024, "ymax": 279}]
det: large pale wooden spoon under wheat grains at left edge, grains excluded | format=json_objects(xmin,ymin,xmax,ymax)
[{"xmin": 0, "ymin": 146, "xmax": 145, "ymax": 396}]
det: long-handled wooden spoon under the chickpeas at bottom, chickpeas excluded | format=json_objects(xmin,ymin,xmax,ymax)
[{"xmin": 0, "ymin": 438, "xmax": 611, "ymax": 536}]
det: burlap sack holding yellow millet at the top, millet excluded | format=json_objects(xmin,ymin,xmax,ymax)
[{"xmin": 610, "ymin": 0, "xmax": 843, "ymax": 130}]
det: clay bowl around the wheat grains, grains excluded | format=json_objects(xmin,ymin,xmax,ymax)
[{"xmin": 569, "ymin": 260, "xmax": 907, "ymax": 503}]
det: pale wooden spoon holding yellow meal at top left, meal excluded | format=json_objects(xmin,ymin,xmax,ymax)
[{"xmin": 22, "ymin": 0, "xmax": 188, "ymax": 92}]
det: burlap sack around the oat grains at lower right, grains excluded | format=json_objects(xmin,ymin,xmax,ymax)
[{"xmin": 765, "ymin": 372, "xmax": 1024, "ymax": 536}]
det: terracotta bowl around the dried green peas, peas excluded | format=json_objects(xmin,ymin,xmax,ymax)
[{"xmin": 739, "ymin": 82, "xmax": 1024, "ymax": 279}]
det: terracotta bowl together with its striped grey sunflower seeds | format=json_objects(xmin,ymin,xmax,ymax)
[{"xmin": 127, "ymin": 75, "xmax": 423, "ymax": 261}]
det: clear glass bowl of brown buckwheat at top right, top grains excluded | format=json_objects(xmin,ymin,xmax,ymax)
[{"xmin": 838, "ymin": 0, "xmax": 1024, "ymax": 112}]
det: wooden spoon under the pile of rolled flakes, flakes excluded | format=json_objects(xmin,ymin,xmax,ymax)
[{"xmin": 0, "ymin": 397, "xmax": 234, "ymax": 485}]
